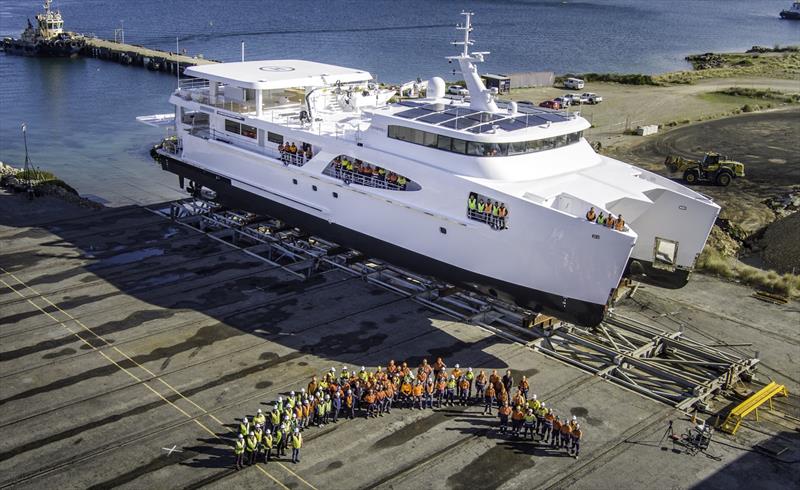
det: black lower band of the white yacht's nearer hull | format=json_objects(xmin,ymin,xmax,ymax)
[{"xmin": 158, "ymin": 156, "xmax": 611, "ymax": 326}]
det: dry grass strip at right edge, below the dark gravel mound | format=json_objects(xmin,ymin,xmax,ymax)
[{"xmin": 697, "ymin": 246, "xmax": 800, "ymax": 298}]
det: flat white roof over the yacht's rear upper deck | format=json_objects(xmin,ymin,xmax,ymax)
[{"xmin": 185, "ymin": 60, "xmax": 372, "ymax": 90}]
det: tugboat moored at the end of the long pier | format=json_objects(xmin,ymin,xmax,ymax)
[{"xmin": 3, "ymin": 0, "xmax": 86, "ymax": 56}]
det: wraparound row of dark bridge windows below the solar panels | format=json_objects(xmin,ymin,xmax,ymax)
[{"xmin": 388, "ymin": 125, "xmax": 583, "ymax": 157}]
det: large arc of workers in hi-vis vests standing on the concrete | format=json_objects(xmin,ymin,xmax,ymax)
[{"xmin": 234, "ymin": 357, "xmax": 581, "ymax": 469}]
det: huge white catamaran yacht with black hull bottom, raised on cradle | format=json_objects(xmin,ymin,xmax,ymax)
[{"xmin": 144, "ymin": 13, "xmax": 719, "ymax": 325}]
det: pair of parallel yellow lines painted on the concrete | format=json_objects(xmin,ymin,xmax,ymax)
[{"xmin": 0, "ymin": 267, "xmax": 308, "ymax": 490}]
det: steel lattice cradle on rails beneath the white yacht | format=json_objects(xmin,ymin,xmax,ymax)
[{"xmin": 151, "ymin": 199, "xmax": 759, "ymax": 412}]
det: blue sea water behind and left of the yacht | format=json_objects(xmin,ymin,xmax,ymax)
[{"xmin": 0, "ymin": 0, "xmax": 800, "ymax": 205}]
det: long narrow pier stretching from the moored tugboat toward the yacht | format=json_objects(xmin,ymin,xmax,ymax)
[{"xmin": 81, "ymin": 38, "xmax": 217, "ymax": 74}]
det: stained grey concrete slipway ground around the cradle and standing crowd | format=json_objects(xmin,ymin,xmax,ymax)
[{"xmin": 0, "ymin": 191, "xmax": 800, "ymax": 490}]
